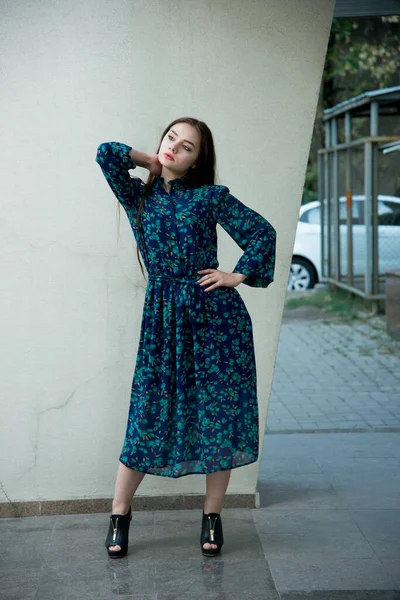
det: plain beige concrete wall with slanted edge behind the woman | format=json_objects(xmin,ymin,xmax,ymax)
[{"xmin": 0, "ymin": 0, "xmax": 334, "ymax": 502}]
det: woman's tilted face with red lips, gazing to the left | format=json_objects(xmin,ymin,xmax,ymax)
[{"xmin": 158, "ymin": 123, "xmax": 200, "ymax": 176}]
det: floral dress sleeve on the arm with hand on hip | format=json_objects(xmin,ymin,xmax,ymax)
[{"xmin": 211, "ymin": 185, "xmax": 276, "ymax": 288}]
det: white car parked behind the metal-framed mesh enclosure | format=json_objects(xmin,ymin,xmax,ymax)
[{"xmin": 288, "ymin": 195, "xmax": 400, "ymax": 290}]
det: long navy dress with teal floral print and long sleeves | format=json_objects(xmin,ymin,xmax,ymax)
[{"xmin": 96, "ymin": 142, "xmax": 276, "ymax": 478}]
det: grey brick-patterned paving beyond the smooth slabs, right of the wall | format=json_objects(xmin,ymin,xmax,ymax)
[{"xmin": 267, "ymin": 317, "xmax": 400, "ymax": 433}]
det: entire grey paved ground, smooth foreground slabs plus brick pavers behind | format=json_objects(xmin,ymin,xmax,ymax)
[{"xmin": 0, "ymin": 312, "xmax": 400, "ymax": 600}]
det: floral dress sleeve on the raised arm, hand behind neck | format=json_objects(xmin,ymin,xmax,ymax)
[{"xmin": 96, "ymin": 142, "xmax": 144, "ymax": 212}]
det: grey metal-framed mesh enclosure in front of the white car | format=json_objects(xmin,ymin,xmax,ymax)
[{"xmin": 318, "ymin": 86, "xmax": 400, "ymax": 301}]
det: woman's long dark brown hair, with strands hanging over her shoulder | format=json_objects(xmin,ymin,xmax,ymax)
[{"xmin": 118, "ymin": 117, "xmax": 216, "ymax": 279}]
